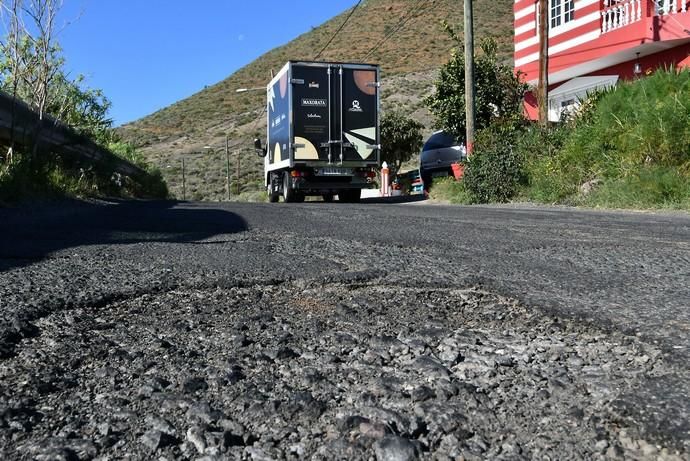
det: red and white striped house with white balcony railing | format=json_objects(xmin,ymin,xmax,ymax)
[{"xmin": 513, "ymin": 0, "xmax": 690, "ymax": 121}]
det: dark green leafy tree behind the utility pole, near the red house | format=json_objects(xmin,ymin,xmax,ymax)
[{"xmin": 425, "ymin": 34, "xmax": 527, "ymax": 139}]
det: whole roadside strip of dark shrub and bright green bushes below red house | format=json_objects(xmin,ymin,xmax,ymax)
[{"xmin": 424, "ymin": 70, "xmax": 690, "ymax": 209}]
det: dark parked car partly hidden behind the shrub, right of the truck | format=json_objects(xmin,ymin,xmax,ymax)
[{"xmin": 419, "ymin": 131, "xmax": 467, "ymax": 189}]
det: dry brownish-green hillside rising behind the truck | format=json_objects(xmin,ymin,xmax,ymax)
[{"xmin": 120, "ymin": 0, "xmax": 513, "ymax": 200}]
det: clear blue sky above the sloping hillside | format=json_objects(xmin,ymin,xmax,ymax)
[{"xmin": 58, "ymin": 0, "xmax": 357, "ymax": 125}]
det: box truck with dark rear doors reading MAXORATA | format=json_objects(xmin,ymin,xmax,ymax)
[{"xmin": 255, "ymin": 61, "xmax": 381, "ymax": 202}]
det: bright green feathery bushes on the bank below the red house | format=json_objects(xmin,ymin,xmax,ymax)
[{"xmin": 516, "ymin": 70, "xmax": 690, "ymax": 208}]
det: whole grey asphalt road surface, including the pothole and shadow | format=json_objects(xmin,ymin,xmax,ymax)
[{"xmin": 0, "ymin": 202, "xmax": 690, "ymax": 459}]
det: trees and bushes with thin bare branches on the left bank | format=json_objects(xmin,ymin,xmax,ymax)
[{"xmin": 0, "ymin": 0, "xmax": 167, "ymax": 197}]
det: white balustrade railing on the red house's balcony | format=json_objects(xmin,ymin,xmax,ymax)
[{"xmin": 601, "ymin": 0, "xmax": 688, "ymax": 33}]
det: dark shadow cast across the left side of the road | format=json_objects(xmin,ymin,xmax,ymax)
[{"xmin": 0, "ymin": 201, "xmax": 247, "ymax": 272}]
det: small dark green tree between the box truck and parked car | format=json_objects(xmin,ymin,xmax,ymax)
[{"xmin": 381, "ymin": 112, "xmax": 423, "ymax": 174}]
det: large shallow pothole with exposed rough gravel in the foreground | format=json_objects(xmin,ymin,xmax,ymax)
[{"xmin": 0, "ymin": 276, "xmax": 687, "ymax": 459}]
